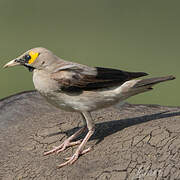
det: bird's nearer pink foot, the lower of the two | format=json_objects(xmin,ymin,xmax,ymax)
[{"xmin": 57, "ymin": 147, "xmax": 92, "ymax": 168}]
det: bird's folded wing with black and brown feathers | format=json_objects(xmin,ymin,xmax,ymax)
[{"xmin": 51, "ymin": 64, "xmax": 148, "ymax": 91}]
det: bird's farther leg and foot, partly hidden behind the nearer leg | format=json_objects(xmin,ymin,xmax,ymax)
[{"xmin": 44, "ymin": 116, "xmax": 86, "ymax": 155}]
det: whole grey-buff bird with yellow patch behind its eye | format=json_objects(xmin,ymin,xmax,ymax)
[{"xmin": 4, "ymin": 47, "xmax": 175, "ymax": 168}]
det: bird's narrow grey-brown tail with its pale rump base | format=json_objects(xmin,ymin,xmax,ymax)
[{"xmin": 117, "ymin": 76, "xmax": 175, "ymax": 100}]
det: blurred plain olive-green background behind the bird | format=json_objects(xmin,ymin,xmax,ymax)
[{"xmin": 0, "ymin": 0, "xmax": 180, "ymax": 106}]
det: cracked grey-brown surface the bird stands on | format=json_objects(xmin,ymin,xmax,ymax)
[{"xmin": 0, "ymin": 91, "xmax": 180, "ymax": 180}]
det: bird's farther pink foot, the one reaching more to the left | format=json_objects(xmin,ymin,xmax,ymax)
[{"xmin": 44, "ymin": 139, "xmax": 81, "ymax": 156}]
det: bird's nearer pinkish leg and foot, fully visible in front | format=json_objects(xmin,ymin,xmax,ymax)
[{"xmin": 58, "ymin": 112, "xmax": 95, "ymax": 168}]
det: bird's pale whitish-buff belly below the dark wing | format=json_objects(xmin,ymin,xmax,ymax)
[{"xmin": 41, "ymin": 88, "xmax": 122, "ymax": 112}]
